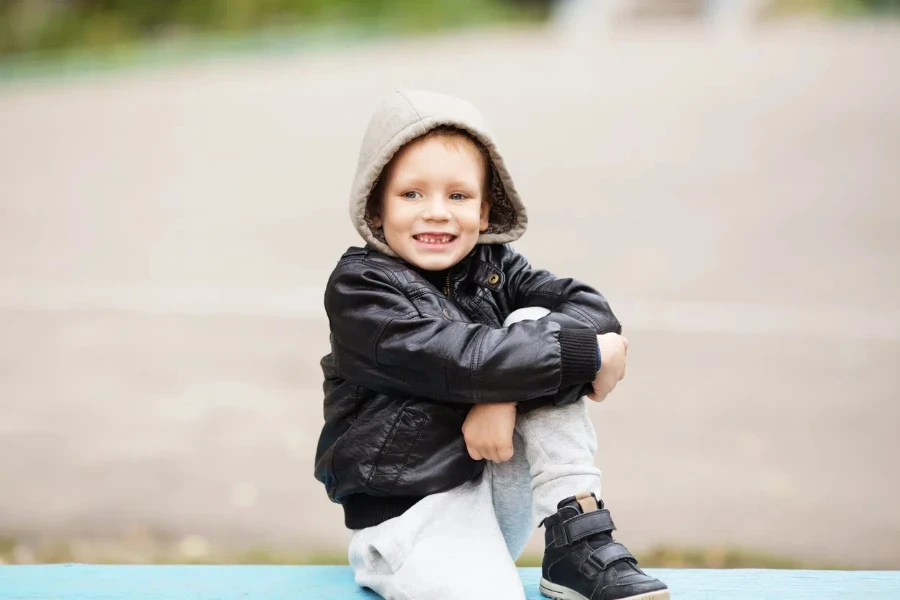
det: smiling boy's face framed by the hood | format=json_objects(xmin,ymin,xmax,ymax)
[{"xmin": 373, "ymin": 136, "xmax": 490, "ymax": 271}]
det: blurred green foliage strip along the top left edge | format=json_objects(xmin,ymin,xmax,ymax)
[{"xmin": 0, "ymin": 0, "xmax": 535, "ymax": 56}]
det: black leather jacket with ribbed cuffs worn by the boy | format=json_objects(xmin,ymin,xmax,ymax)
[{"xmin": 315, "ymin": 245, "xmax": 621, "ymax": 529}]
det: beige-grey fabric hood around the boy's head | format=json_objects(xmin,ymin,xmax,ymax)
[{"xmin": 350, "ymin": 90, "xmax": 528, "ymax": 256}]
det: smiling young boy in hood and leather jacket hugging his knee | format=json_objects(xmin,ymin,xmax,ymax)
[{"xmin": 315, "ymin": 92, "xmax": 669, "ymax": 600}]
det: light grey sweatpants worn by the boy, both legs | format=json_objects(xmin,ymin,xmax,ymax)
[{"xmin": 349, "ymin": 309, "xmax": 600, "ymax": 600}]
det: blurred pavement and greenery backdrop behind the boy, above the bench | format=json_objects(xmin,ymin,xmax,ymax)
[{"xmin": 0, "ymin": 0, "xmax": 900, "ymax": 568}]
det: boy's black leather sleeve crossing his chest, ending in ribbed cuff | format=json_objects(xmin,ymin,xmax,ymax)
[{"xmin": 325, "ymin": 260, "xmax": 598, "ymax": 403}]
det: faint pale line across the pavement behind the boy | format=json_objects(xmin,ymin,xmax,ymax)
[{"xmin": 0, "ymin": 282, "xmax": 900, "ymax": 340}]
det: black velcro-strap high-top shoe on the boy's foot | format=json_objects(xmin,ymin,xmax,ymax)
[{"xmin": 541, "ymin": 493, "xmax": 669, "ymax": 600}]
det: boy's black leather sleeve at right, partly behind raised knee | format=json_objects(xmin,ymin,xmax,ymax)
[{"xmin": 504, "ymin": 246, "xmax": 622, "ymax": 335}]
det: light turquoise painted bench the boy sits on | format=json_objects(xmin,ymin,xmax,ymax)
[{"xmin": 0, "ymin": 565, "xmax": 900, "ymax": 600}]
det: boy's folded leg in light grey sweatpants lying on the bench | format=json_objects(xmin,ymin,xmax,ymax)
[{"xmin": 349, "ymin": 473, "xmax": 525, "ymax": 600}]
